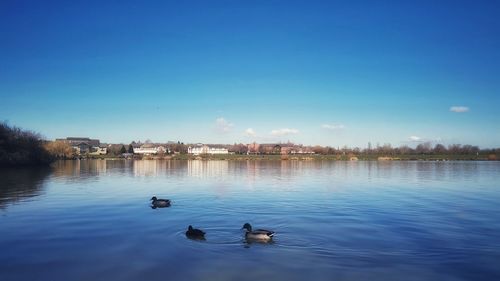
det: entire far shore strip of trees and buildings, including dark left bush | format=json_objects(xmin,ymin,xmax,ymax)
[{"xmin": 0, "ymin": 123, "xmax": 500, "ymax": 167}]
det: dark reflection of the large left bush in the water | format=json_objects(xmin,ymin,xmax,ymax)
[{"xmin": 0, "ymin": 168, "xmax": 51, "ymax": 209}]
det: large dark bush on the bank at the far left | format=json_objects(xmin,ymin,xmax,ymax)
[{"xmin": 0, "ymin": 122, "xmax": 54, "ymax": 166}]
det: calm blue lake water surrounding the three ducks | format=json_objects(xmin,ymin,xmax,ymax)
[{"xmin": 0, "ymin": 160, "xmax": 500, "ymax": 281}]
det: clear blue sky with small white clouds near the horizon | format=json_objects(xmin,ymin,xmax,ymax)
[{"xmin": 0, "ymin": 0, "xmax": 500, "ymax": 148}]
